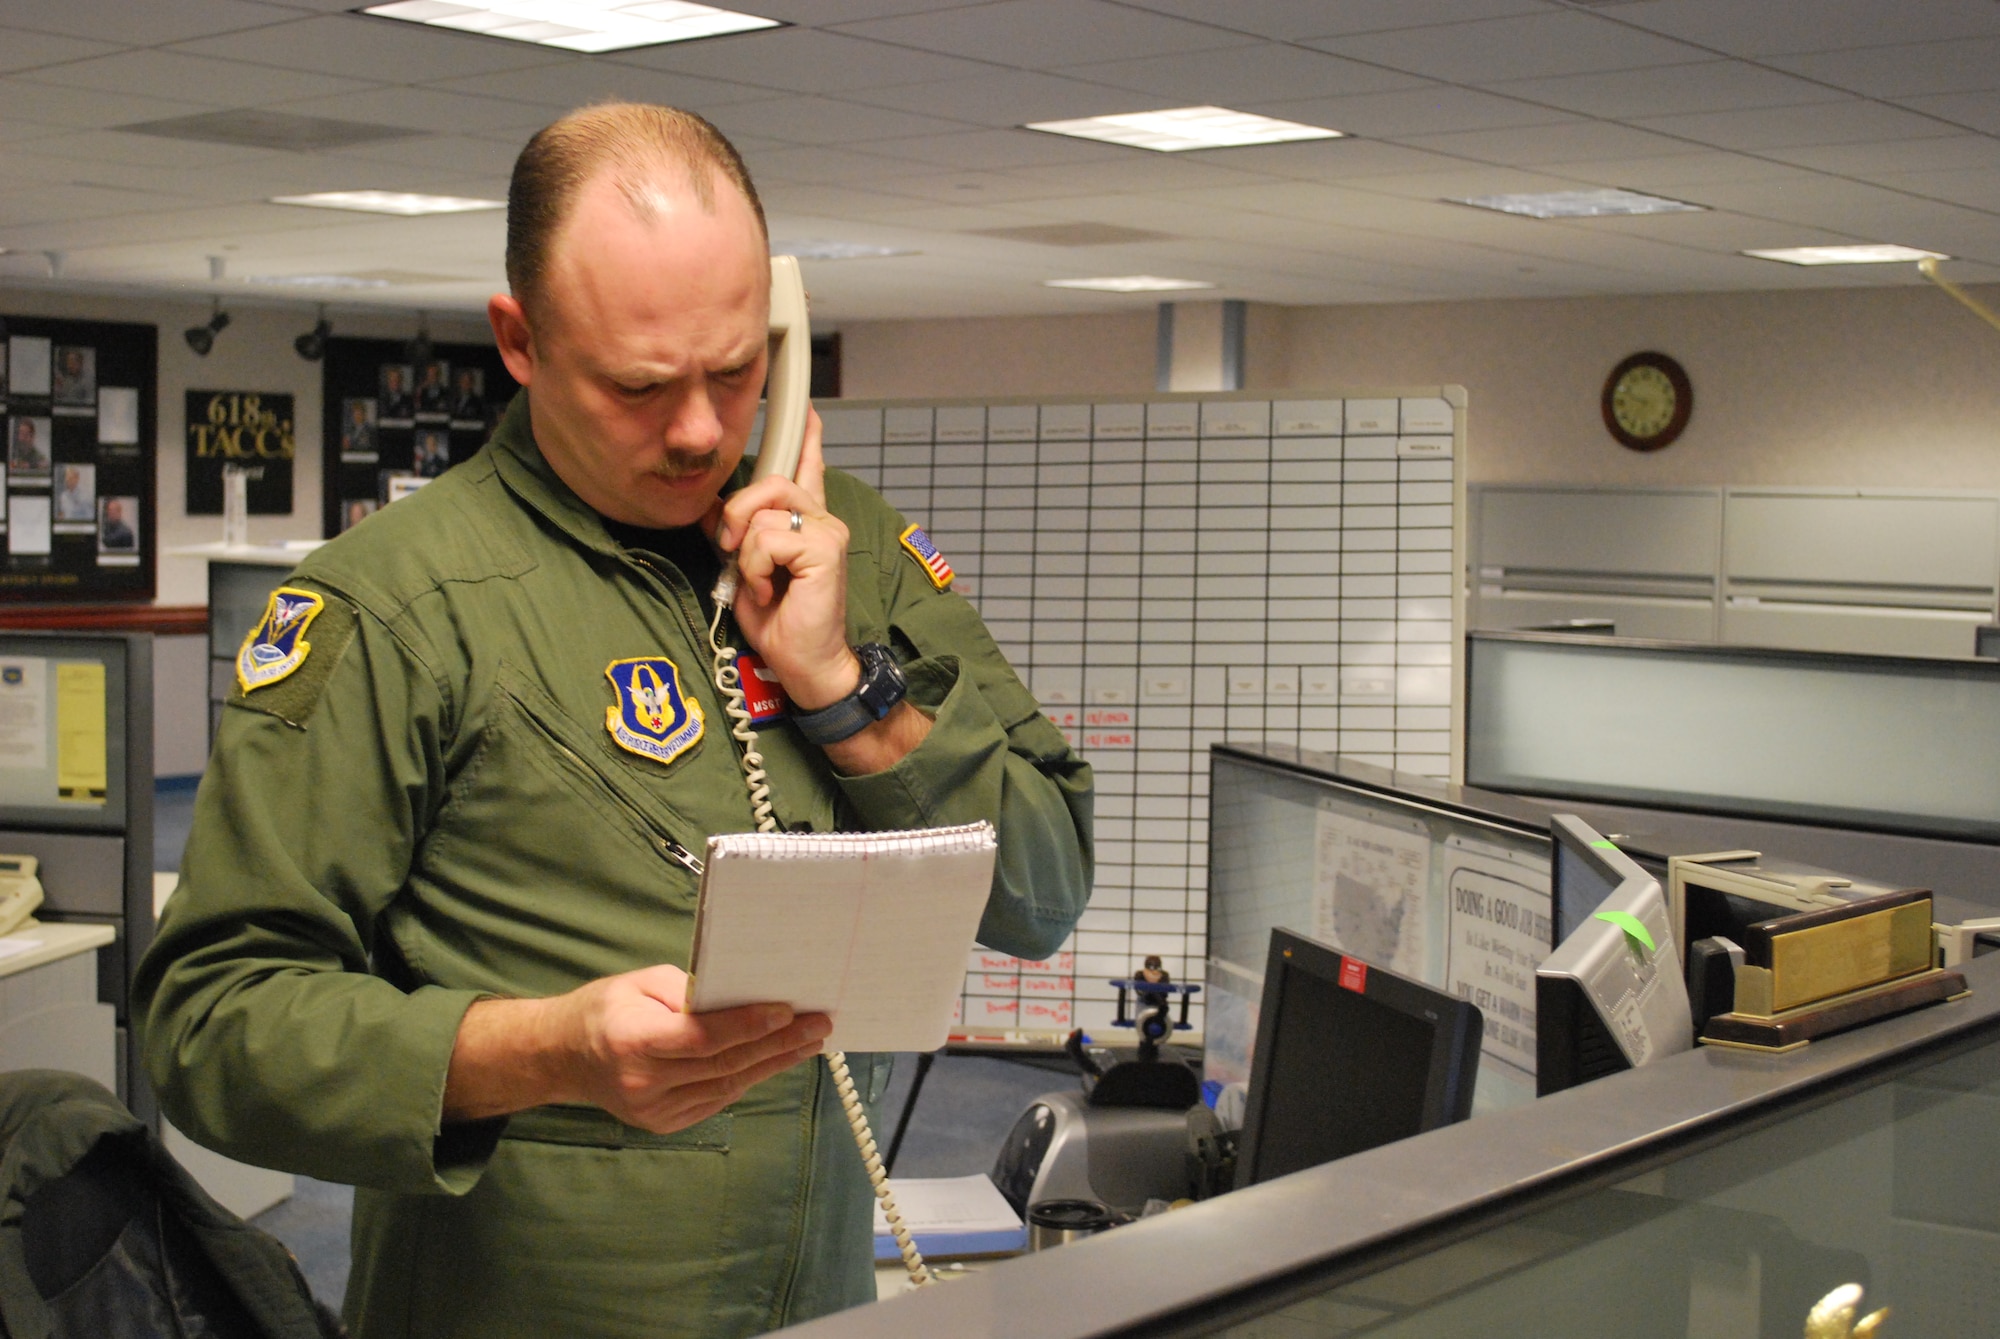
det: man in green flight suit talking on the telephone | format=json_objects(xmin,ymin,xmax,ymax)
[{"xmin": 138, "ymin": 104, "xmax": 1090, "ymax": 1339}]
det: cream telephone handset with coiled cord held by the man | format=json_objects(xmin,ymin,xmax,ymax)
[{"xmin": 708, "ymin": 256, "xmax": 932, "ymax": 1283}]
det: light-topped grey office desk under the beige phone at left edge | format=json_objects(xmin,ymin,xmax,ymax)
[{"xmin": 0, "ymin": 921, "xmax": 118, "ymax": 1091}]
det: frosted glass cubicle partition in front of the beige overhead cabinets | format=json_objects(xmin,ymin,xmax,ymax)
[{"xmin": 1466, "ymin": 634, "xmax": 2000, "ymax": 843}]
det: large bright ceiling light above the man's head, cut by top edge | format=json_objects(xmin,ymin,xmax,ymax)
[{"xmin": 360, "ymin": 0, "xmax": 782, "ymax": 52}]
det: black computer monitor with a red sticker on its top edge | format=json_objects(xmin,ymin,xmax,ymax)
[{"xmin": 1236, "ymin": 929, "xmax": 1484, "ymax": 1185}]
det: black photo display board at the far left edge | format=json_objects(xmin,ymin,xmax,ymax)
[{"xmin": 0, "ymin": 316, "xmax": 158, "ymax": 604}]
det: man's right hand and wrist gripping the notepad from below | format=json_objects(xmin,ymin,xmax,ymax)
[{"xmin": 444, "ymin": 967, "xmax": 832, "ymax": 1133}]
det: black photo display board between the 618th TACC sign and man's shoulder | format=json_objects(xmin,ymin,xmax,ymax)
[{"xmin": 320, "ymin": 336, "xmax": 518, "ymax": 540}]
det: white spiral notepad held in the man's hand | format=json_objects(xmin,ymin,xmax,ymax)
[{"xmin": 688, "ymin": 823, "xmax": 994, "ymax": 1051}]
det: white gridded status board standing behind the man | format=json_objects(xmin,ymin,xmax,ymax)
[{"xmin": 820, "ymin": 386, "xmax": 1466, "ymax": 1043}]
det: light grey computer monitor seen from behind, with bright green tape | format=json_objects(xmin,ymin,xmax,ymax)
[{"xmin": 1534, "ymin": 813, "xmax": 1694, "ymax": 1097}]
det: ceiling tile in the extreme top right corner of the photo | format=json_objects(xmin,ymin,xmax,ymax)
[{"xmin": 1610, "ymin": 0, "xmax": 2000, "ymax": 56}]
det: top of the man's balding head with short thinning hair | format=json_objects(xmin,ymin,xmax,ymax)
[{"xmin": 506, "ymin": 102, "xmax": 768, "ymax": 325}]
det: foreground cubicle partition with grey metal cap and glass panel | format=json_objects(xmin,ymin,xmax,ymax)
[{"xmin": 788, "ymin": 939, "xmax": 2000, "ymax": 1339}]
